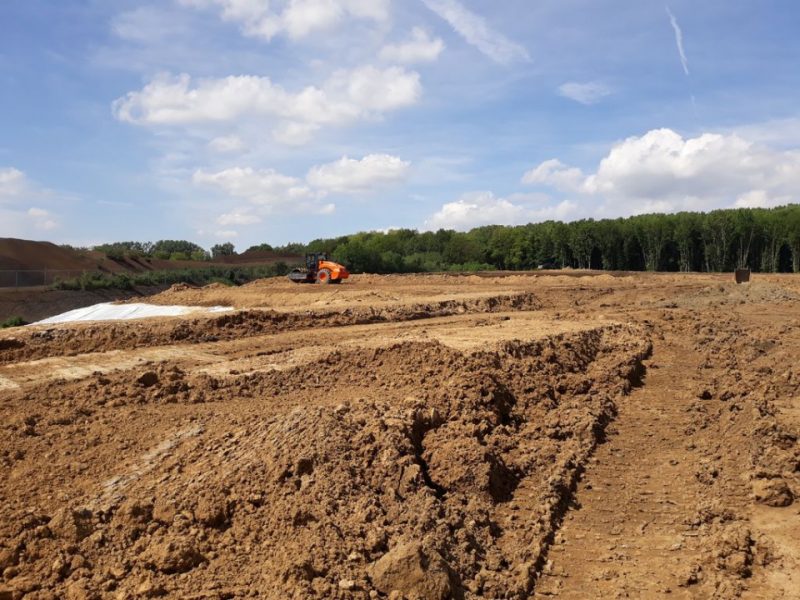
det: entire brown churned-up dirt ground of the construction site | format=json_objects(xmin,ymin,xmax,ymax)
[{"xmin": 0, "ymin": 272, "xmax": 800, "ymax": 600}]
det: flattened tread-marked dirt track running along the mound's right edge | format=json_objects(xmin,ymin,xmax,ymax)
[{"xmin": 536, "ymin": 330, "xmax": 701, "ymax": 600}]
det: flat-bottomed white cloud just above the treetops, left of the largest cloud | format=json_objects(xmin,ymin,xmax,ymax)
[{"xmin": 424, "ymin": 192, "xmax": 577, "ymax": 231}]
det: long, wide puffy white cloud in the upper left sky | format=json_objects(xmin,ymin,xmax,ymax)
[{"xmin": 112, "ymin": 66, "xmax": 422, "ymax": 143}]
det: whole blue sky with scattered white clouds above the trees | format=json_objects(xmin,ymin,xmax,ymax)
[{"xmin": 0, "ymin": 0, "xmax": 800, "ymax": 250}]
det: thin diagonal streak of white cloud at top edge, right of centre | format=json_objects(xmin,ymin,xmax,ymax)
[{"xmin": 422, "ymin": 0, "xmax": 530, "ymax": 64}]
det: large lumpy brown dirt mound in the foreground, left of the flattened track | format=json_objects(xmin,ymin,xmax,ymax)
[{"xmin": 0, "ymin": 326, "xmax": 649, "ymax": 600}]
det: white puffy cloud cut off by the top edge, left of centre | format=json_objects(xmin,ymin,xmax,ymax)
[{"xmin": 179, "ymin": 0, "xmax": 391, "ymax": 40}]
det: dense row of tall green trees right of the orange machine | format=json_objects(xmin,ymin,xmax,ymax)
[{"xmin": 282, "ymin": 204, "xmax": 800, "ymax": 273}]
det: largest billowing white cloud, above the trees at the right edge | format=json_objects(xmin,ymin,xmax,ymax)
[{"xmin": 523, "ymin": 129, "xmax": 800, "ymax": 214}]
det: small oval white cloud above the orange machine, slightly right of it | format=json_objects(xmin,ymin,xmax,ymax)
[{"xmin": 306, "ymin": 154, "xmax": 410, "ymax": 193}]
